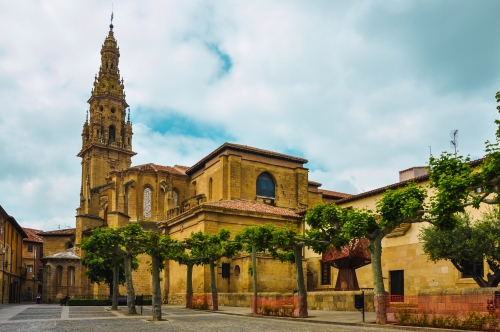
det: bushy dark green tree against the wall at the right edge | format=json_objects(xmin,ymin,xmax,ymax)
[{"xmin": 420, "ymin": 208, "xmax": 500, "ymax": 287}]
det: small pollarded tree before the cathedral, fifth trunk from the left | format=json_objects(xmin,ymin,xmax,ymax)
[{"xmin": 186, "ymin": 229, "xmax": 241, "ymax": 311}]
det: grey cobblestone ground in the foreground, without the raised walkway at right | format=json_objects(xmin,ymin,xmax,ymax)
[{"xmin": 0, "ymin": 307, "xmax": 410, "ymax": 332}]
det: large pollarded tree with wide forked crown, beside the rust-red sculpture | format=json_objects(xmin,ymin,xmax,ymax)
[{"xmin": 305, "ymin": 183, "xmax": 427, "ymax": 324}]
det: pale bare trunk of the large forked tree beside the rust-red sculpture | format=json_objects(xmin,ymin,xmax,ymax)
[{"xmin": 370, "ymin": 232, "xmax": 387, "ymax": 324}]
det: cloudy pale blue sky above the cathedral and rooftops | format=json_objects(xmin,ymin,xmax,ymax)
[{"xmin": 0, "ymin": 0, "xmax": 500, "ymax": 231}]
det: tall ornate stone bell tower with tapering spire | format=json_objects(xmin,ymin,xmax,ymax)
[{"xmin": 77, "ymin": 18, "xmax": 136, "ymax": 219}]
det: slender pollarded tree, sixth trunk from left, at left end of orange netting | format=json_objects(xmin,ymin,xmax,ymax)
[{"xmin": 235, "ymin": 224, "xmax": 275, "ymax": 315}]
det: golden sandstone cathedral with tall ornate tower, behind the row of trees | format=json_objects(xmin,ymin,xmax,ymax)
[{"xmin": 43, "ymin": 25, "xmax": 350, "ymax": 303}]
